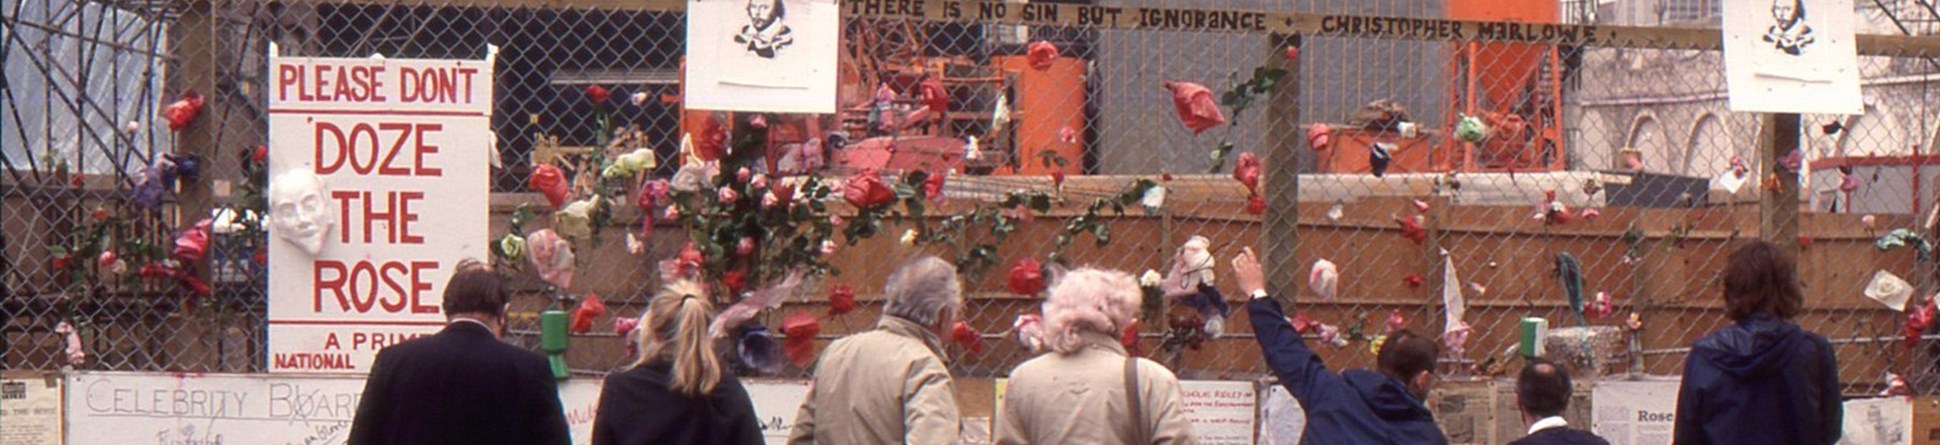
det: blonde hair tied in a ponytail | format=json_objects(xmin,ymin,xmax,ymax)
[{"xmin": 631, "ymin": 282, "xmax": 722, "ymax": 396}]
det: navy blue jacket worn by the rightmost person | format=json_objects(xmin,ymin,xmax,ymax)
[{"xmin": 1674, "ymin": 315, "xmax": 1843, "ymax": 445}]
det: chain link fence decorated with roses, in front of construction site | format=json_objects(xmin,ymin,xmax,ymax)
[{"xmin": 0, "ymin": 0, "xmax": 1940, "ymax": 394}]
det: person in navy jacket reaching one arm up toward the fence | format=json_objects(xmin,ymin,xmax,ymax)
[{"xmin": 1232, "ymin": 249, "xmax": 1447, "ymax": 445}]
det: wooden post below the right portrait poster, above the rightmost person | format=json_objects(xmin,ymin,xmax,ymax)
[{"xmin": 1758, "ymin": 113, "xmax": 1798, "ymax": 255}]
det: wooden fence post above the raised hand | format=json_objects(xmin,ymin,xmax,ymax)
[{"xmin": 1259, "ymin": 35, "xmax": 1308, "ymax": 301}]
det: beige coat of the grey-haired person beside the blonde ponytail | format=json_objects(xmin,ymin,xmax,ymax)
[{"xmin": 788, "ymin": 317, "xmax": 960, "ymax": 445}]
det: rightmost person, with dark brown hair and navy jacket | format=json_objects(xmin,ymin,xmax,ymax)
[{"xmin": 1674, "ymin": 241, "xmax": 1843, "ymax": 445}]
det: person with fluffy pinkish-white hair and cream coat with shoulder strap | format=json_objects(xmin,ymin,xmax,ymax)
[{"xmin": 995, "ymin": 268, "xmax": 1197, "ymax": 445}]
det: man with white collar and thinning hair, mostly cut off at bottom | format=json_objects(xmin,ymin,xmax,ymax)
[{"xmin": 1509, "ymin": 358, "xmax": 1610, "ymax": 445}]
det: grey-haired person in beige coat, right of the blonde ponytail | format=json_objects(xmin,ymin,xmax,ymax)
[{"xmin": 788, "ymin": 257, "xmax": 962, "ymax": 445}]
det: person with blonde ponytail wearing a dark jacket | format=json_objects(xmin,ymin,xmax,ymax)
[{"xmin": 594, "ymin": 282, "xmax": 762, "ymax": 445}]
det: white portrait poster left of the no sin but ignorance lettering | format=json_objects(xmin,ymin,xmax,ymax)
[{"xmin": 685, "ymin": 0, "xmax": 842, "ymax": 113}]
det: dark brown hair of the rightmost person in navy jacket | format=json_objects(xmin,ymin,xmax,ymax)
[{"xmin": 1725, "ymin": 241, "xmax": 1804, "ymax": 321}]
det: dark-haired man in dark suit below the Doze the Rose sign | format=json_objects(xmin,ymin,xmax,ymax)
[{"xmin": 349, "ymin": 260, "xmax": 570, "ymax": 445}]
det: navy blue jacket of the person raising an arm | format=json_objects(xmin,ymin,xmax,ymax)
[{"xmin": 1245, "ymin": 297, "xmax": 1447, "ymax": 445}]
